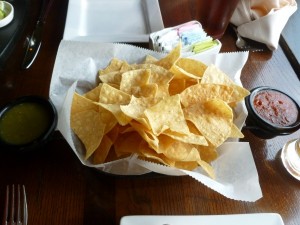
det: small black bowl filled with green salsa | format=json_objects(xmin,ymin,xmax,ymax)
[{"xmin": 0, "ymin": 96, "xmax": 57, "ymax": 151}]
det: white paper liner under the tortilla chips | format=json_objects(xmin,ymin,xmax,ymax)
[{"xmin": 50, "ymin": 40, "xmax": 262, "ymax": 201}]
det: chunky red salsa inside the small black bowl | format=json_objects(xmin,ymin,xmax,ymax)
[{"xmin": 253, "ymin": 90, "xmax": 299, "ymax": 127}]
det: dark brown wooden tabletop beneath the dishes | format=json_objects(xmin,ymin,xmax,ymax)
[{"xmin": 0, "ymin": 0, "xmax": 300, "ymax": 225}]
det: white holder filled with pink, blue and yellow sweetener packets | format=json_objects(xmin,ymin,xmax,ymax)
[{"xmin": 149, "ymin": 20, "xmax": 222, "ymax": 57}]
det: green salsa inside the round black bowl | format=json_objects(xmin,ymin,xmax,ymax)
[{"xmin": 0, "ymin": 102, "xmax": 51, "ymax": 145}]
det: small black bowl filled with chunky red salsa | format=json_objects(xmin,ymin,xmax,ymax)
[{"xmin": 245, "ymin": 86, "xmax": 300, "ymax": 139}]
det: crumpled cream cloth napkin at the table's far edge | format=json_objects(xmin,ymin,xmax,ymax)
[{"xmin": 230, "ymin": 0, "xmax": 297, "ymax": 50}]
